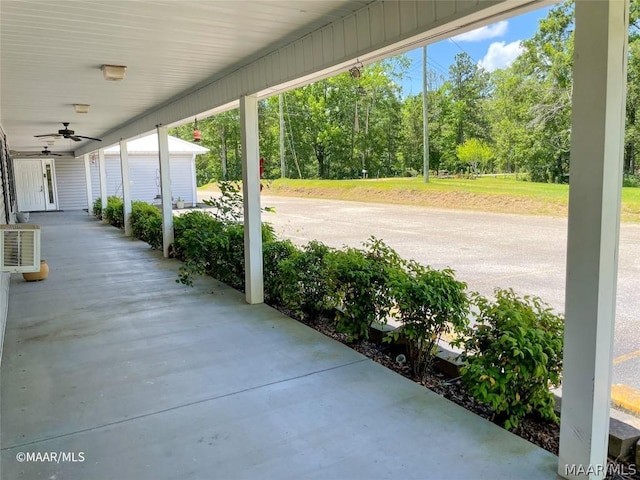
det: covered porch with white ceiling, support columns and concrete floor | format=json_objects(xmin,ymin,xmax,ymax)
[{"xmin": 0, "ymin": 0, "xmax": 629, "ymax": 478}]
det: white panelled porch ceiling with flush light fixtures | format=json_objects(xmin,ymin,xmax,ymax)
[{"xmin": 0, "ymin": 0, "xmax": 372, "ymax": 152}]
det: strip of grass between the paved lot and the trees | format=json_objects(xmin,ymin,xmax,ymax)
[{"xmin": 201, "ymin": 176, "xmax": 640, "ymax": 223}]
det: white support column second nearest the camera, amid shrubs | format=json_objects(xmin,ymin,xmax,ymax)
[{"xmin": 240, "ymin": 95, "xmax": 264, "ymax": 303}]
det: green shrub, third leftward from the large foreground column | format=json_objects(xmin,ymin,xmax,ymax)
[{"xmin": 330, "ymin": 237, "xmax": 402, "ymax": 340}]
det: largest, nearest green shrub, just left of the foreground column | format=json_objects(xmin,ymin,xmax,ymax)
[{"xmin": 461, "ymin": 290, "xmax": 564, "ymax": 430}]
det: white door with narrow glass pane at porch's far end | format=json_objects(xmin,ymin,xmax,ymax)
[{"xmin": 14, "ymin": 159, "xmax": 57, "ymax": 212}]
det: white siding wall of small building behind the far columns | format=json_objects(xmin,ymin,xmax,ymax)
[{"xmin": 91, "ymin": 154, "xmax": 196, "ymax": 205}]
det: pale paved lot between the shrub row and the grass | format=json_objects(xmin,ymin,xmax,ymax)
[{"xmin": 252, "ymin": 196, "xmax": 640, "ymax": 396}]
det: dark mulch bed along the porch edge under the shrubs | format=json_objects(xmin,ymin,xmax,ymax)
[{"xmin": 284, "ymin": 311, "xmax": 640, "ymax": 480}]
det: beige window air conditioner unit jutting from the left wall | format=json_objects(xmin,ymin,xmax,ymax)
[{"xmin": 0, "ymin": 224, "xmax": 40, "ymax": 273}]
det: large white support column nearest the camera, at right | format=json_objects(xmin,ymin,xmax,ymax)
[{"xmin": 558, "ymin": 0, "xmax": 629, "ymax": 479}]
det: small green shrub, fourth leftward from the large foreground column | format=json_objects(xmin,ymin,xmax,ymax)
[{"xmin": 279, "ymin": 240, "xmax": 333, "ymax": 320}]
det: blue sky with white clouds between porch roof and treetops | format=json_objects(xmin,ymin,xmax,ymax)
[{"xmin": 402, "ymin": 7, "xmax": 551, "ymax": 95}]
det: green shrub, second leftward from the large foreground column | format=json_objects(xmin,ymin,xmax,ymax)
[{"xmin": 387, "ymin": 262, "xmax": 469, "ymax": 377}]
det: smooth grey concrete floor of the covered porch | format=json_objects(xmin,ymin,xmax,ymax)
[{"xmin": 0, "ymin": 212, "xmax": 557, "ymax": 480}]
